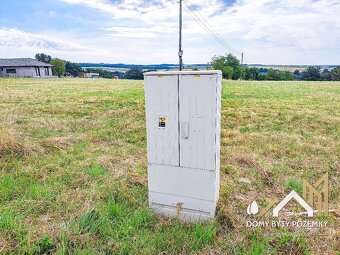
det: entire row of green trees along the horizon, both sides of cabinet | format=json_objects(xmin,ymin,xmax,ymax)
[{"xmin": 35, "ymin": 53, "xmax": 340, "ymax": 81}]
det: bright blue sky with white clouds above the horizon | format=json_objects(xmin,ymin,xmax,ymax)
[{"xmin": 0, "ymin": 0, "xmax": 340, "ymax": 65}]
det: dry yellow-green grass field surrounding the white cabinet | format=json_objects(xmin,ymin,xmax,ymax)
[{"xmin": 0, "ymin": 79, "xmax": 340, "ymax": 254}]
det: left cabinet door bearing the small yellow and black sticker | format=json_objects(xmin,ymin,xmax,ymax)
[{"xmin": 144, "ymin": 75, "xmax": 179, "ymax": 166}]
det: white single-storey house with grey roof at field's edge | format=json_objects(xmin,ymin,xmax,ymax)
[{"xmin": 0, "ymin": 58, "xmax": 52, "ymax": 78}]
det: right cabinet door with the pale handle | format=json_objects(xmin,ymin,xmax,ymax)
[{"xmin": 179, "ymin": 75, "xmax": 217, "ymax": 170}]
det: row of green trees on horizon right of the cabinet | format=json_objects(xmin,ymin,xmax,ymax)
[{"xmin": 209, "ymin": 54, "xmax": 340, "ymax": 81}]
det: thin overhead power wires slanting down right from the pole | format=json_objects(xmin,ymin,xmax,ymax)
[{"xmin": 183, "ymin": 0, "xmax": 240, "ymax": 55}]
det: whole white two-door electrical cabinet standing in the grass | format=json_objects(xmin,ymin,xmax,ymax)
[{"xmin": 144, "ymin": 71, "xmax": 222, "ymax": 221}]
